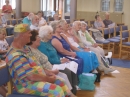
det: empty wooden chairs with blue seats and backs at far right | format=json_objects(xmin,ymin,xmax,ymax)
[{"xmin": 90, "ymin": 25, "xmax": 130, "ymax": 58}]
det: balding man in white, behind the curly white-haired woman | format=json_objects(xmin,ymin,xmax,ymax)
[{"xmin": 30, "ymin": 15, "xmax": 39, "ymax": 30}]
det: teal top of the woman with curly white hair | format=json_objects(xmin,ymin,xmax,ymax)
[{"xmin": 38, "ymin": 41, "xmax": 61, "ymax": 64}]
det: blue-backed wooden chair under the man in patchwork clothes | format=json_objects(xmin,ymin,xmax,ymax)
[{"xmin": 0, "ymin": 65, "xmax": 41, "ymax": 97}]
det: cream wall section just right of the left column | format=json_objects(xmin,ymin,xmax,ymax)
[{"xmin": 22, "ymin": 0, "xmax": 40, "ymax": 13}]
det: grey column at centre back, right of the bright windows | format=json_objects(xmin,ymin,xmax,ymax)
[{"xmin": 70, "ymin": 0, "xmax": 77, "ymax": 22}]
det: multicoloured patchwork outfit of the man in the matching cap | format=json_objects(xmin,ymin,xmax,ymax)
[{"xmin": 6, "ymin": 46, "xmax": 70, "ymax": 97}]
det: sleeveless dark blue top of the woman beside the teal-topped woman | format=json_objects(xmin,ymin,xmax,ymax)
[{"xmin": 52, "ymin": 36, "xmax": 70, "ymax": 57}]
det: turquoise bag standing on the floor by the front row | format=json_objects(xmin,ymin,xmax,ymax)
[{"xmin": 78, "ymin": 73, "xmax": 97, "ymax": 91}]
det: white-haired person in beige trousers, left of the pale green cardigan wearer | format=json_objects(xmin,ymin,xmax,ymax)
[{"xmin": 73, "ymin": 21, "xmax": 114, "ymax": 74}]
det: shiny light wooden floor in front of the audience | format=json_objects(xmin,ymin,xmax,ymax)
[{"xmin": 77, "ymin": 67, "xmax": 130, "ymax": 97}]
